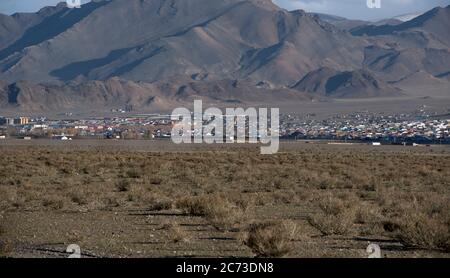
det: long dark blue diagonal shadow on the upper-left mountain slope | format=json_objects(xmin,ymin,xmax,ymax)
[{"xmin": 0, "ymin": 1, "xmax": 108, "ymax": 60}]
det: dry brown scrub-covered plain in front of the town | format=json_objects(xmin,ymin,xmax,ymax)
[{"xmin": 0, "ymin": 140, "xmax": 450, "ymax": 257}]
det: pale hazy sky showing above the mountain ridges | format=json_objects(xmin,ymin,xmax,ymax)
[{"xmin": 0, "ymin": 0, "xmax": 450, "ymax": 20}]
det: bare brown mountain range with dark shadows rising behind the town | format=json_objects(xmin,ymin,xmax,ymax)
[{"xmin": 0, "ymin": 0, "xmax": 450, "ymax": 112}]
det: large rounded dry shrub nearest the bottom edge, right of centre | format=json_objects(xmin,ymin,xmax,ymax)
[{"xmin": 243, "ymin": 221, "xmax": 297, "ymax": 257}]
